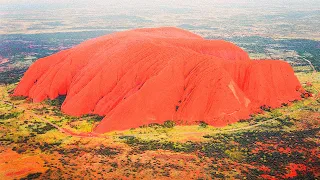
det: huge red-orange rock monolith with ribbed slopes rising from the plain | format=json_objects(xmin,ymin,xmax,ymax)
[{"xmin": 14, "ymin": 28, "xmax": 301, "ymax": 133}]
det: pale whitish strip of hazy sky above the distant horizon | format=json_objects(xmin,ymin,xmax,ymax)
[{"xmin": 0, "ymin": 0, "xmax": 320, "ymax": 11}]
